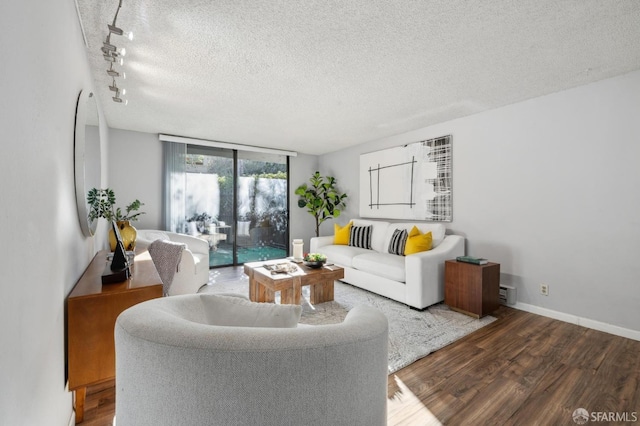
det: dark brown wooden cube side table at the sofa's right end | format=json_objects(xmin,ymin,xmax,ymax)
[{"xmin": 444, "ymin": 260, "xmax": 500, "ymax": 318}]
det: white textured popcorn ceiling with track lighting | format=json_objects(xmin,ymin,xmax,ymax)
[{"xmin": 77, "ymin": 0, "xmax": 640, "ymax": 154}]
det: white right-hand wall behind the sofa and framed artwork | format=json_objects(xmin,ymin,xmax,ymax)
[{"xmin": 319, "ymin": 71, "xmax": 640, "ymax": 335}]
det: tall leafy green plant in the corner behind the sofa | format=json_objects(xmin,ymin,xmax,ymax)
[{"xmin": 295, "ymin": 171, "xmax": 347, "ymax": 237}]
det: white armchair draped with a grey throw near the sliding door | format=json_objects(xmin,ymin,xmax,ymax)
[{"xmin": 136, "ymin": 229, "xmax": 209, "ymax": 296}]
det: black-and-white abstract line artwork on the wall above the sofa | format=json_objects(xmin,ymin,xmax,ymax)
[{"xmin": 360, "ymin": 135, "xmax": 453, "ymax": 222}]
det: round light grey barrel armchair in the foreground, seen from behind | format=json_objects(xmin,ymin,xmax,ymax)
[{"xmin": 115, "ymin": 294, "xmax": 388, "ymax": 426}]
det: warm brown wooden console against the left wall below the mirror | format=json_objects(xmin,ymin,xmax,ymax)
[{"xmin": 67, "ymin": 250, "xmax": 162, "ymax": 423}]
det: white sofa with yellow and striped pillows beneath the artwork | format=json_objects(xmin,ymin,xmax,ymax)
[{"xmin": 310, "ymin": 219, "xmax": 465, "ymax": 309}]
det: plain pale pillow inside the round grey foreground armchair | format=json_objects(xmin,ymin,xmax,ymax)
[{"xmin": 200, "ymin": 294, "xmax": 302, "ymax": 328}]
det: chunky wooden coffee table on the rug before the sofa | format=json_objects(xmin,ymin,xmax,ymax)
[{"xmin": 244, "ymin": 259, "xmax": 344, "ymax": 305}]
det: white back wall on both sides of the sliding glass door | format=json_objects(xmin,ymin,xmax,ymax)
[{"xmin": 109, "ymin": 129, "xmax": 320, "ymax": 250}]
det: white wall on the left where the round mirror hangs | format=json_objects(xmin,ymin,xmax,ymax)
[{"xmin": 0, "ymin": 0, "xmax": 107, "ymax": 426}]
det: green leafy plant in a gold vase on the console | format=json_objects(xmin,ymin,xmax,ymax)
[{"xmin": 87, "ymin": 188, "xmax": 144, "ymax": 251}]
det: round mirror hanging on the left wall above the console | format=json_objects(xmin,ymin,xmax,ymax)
[{"xmin": 74, "ymin": 90, "xmax": 102, "ymax": 237}]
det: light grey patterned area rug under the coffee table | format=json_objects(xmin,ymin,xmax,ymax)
[{"xmin": 200, "ymin": 275, "xmax": 496, "ymax": 373}]
